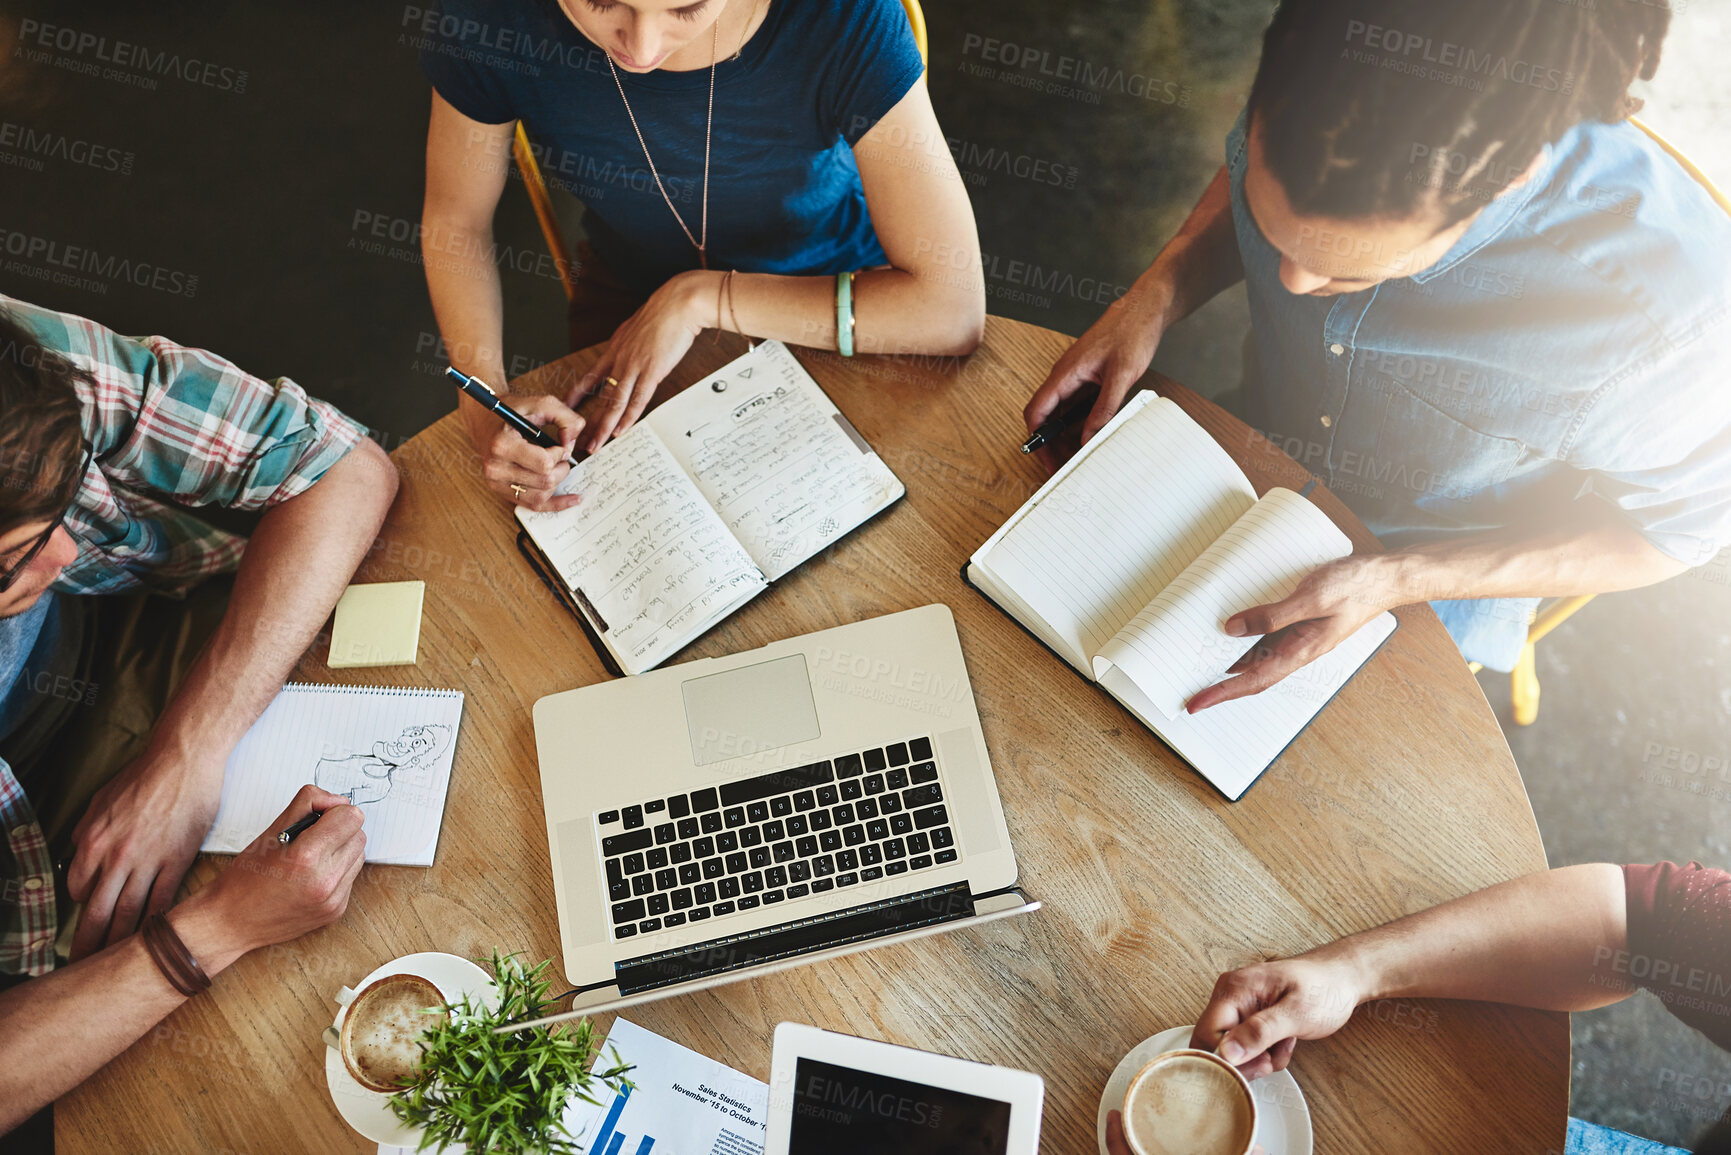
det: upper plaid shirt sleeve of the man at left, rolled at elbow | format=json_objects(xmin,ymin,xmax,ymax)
[{"xmin": 0, "ymin": 298, "xmax": 365, "ymax": 594}]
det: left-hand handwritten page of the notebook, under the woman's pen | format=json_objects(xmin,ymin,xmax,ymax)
[{"xmin": 518, "ymin": 424, "xmax": 765, "ymax": 674}]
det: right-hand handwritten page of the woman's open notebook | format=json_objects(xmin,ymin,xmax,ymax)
[{"xmin": 647, "ymin": 341, "xmax": 904, "ymax": 582}]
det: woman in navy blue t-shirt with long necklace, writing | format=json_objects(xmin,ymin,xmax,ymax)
[{"xmin": 418, "ymin": 0, "xmax": 985, "ymax": 509}]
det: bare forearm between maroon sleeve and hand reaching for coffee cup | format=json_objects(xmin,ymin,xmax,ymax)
[{"xmin": 1300, "ymin": 862, "xmax": 1627, "ymax": 1011}]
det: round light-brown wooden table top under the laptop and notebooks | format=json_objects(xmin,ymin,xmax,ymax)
[{"xmin": 55, "ymin": 319, "xmax": 1568, "ymax": 1155}]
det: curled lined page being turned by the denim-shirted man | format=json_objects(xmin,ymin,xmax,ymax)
[{"xmin": 1094, "ymin": 488, "xmax": 1352, "ymax": 719}]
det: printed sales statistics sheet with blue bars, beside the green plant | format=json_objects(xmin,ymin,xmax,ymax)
[{"xmin": 564, "ymin": 1018, "xmax": 769, "ymax": 1155}]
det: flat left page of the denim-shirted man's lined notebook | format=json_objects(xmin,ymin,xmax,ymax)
[{"xmin": 973, "ymin": 393, "xmax": 1257, "ymax": 677}]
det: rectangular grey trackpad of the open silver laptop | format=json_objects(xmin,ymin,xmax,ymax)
[{"xmin": 680, "ymin": 655, "xmax": 820, "ymax": 765}]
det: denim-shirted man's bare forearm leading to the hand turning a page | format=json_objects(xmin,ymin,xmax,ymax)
[{"xmin": 1378, "ymin": 523, "xmax": 1688, "ymax": 604}]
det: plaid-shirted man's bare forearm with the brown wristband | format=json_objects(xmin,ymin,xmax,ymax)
[{"xmin": 0, "ymin": 899, "xmax": 241, "ymax": 1134}]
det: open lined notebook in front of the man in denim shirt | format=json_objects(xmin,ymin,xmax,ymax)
[{"xmin": 964, "ymin": 393, "xmax": 1395, "ymax": 802}]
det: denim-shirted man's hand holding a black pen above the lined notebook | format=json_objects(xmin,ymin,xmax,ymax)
[{"xmin": 1021, "ymin": 287, "xmax": 1165, "ymax": 469}]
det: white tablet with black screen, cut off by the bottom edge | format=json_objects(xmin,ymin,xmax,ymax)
[{"xmin": 765, "ymin": 1023, "xmax": 1046, "ymax": 1155}]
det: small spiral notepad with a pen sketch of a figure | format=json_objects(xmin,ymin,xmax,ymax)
[{"xmin": 201, "ymin": 682, "xmax": 462, "ymax": 866}]
